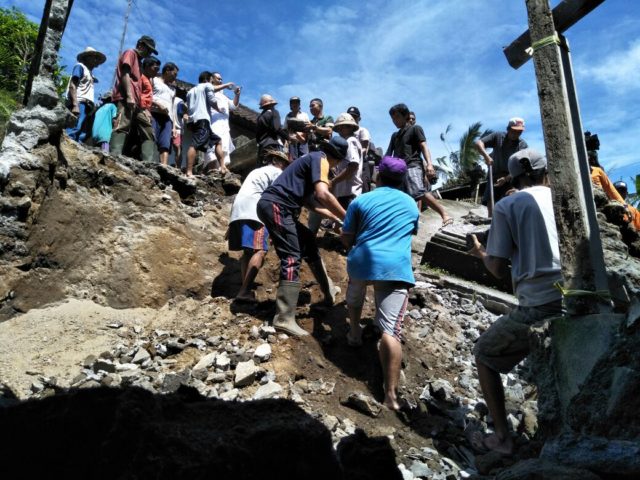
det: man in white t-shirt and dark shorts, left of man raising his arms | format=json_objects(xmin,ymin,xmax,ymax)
[{"xmin": 186, "ymin": 71, "xmax": 224, "ymax": 177}]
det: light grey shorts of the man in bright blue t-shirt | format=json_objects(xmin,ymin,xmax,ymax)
[{"xmin": 347, "ymin": 278, "xmax": 409, "ymax": 341}]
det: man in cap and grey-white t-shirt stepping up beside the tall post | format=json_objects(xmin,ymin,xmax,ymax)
[{"xmin": 469, "ymin": 149, "xmax": 562, "ymax": 454}]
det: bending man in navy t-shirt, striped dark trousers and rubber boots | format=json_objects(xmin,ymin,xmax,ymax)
[{"xmin": 258, "ymin": 137, "xmax": 349, "ymax": 336}]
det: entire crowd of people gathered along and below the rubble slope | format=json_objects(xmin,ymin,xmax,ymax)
[{"xmin": 67, "ymin": 36, "xmax": 640, "ymax": 454}]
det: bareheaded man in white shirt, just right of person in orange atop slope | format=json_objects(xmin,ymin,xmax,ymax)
[{"xmin": 151, "ymin": 62, "xmax": 179, "ymax": 165}]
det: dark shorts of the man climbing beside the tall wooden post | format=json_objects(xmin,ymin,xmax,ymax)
[{"xmin": 473, "ymin": 300, "xmax": 562, "ymax": 373}]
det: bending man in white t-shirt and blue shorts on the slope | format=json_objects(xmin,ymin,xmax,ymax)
[{"xmin": 228, "ymin": 150, "xmax": 289, "ymax": 302}]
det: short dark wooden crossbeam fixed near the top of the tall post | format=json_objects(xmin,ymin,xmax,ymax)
[{"xmin": 503, "ymin": 0, "xmax": 604, "ymax": 70}]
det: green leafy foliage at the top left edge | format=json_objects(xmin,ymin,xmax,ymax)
[{"xmin": 0, "ymin": 7, "xmax": 38, "ymax": 100}]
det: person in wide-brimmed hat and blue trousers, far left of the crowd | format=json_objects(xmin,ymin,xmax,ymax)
[{"xmin": 66, "ymin": 47, "xmax": 107, "ymax": 142}]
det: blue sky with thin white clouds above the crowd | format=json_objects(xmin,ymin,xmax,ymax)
[{"xmin": 0, "ymin": 0, "xmax": 640, "ymax": 191}]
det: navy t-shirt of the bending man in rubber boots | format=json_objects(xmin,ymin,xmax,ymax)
[{"xmin": 262, "ymin": 152, "xmax": 330, "ymax": 213}]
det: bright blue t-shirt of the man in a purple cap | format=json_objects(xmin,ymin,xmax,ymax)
[{"xmin": 342, "ymin": 186, "xmax": 420, "ymax": 285}]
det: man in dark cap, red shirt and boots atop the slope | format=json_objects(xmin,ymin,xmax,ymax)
[{"xmin": 109, "ymin": 35, "xmax": 158, "ymax": 159}]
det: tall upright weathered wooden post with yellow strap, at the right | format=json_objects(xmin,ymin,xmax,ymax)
[{"xmin": 505, "ymin": 0, "xmax": 611, "ymax": 315}]
